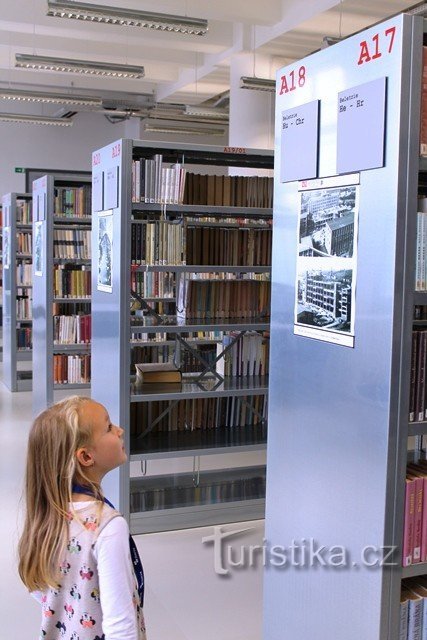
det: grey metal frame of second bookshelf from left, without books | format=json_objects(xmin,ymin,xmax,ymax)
[{"xmin": 33, "ymin": 172, "xmax": 91, "ymax": 414}]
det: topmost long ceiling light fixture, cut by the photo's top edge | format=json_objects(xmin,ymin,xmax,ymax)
[{"xmin": 47, "ymin": 0, "xmax": 208, "ymax": 36}]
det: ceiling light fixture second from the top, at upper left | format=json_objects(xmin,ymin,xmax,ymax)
[{"xmin": 15, "ymin": 53, "xmax": 144, "ymax": 79}]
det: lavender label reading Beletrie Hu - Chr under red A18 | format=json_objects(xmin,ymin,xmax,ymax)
[{"xmin": 280, "ymin": 100, "xmax": 320, "ymax": 182}]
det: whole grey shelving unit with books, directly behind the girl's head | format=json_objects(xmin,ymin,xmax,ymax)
[{"xmin": 92, "ymin": 139, "xmax": 273, "ymax": 533}]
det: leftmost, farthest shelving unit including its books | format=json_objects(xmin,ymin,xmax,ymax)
[{"xmin": 3, "ymin": 193, "xmax": 32, "ymax": 391}]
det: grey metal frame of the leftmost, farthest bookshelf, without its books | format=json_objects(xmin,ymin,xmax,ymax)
[{"xmin": 3, "ymin": 193, "xmax": 32, "ymax": 391}]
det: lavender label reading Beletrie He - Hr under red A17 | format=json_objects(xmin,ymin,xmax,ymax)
[{"xmin": 337, "ymin": 77, "xmax": 387, "ymax": 173}]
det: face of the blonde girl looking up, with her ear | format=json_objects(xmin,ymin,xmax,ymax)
[{"xmin": 81, "ymin": 400, "xmax": 127, "ymax": 482}]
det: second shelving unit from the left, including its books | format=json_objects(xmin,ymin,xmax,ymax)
[{"xmin": 33, "ymin": 172, "xmax": 91, "ymax": 413}]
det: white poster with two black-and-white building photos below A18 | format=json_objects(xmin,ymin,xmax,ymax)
[{"xmin": 294, "ymin": 174, "xmax": 359, "ymax": 347}]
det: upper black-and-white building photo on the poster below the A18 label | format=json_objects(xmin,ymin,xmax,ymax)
[{"xmin": 298, "ymin": 185, "xmax": 358, "ymax": 258}]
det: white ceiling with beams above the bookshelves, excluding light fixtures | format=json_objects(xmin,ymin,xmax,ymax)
[{"xmin": 0, "ymin": 0, "xmax": 414, "ymax": 119}]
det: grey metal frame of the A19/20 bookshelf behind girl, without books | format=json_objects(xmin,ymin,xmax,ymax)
[{"xmin": 92, "ymin": 140, "xmax": 273, "ymax": 533}]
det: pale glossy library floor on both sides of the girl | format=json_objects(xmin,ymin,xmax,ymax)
[{"xmin": 0, "ymin": 363, "xmax": 264, "ymax": 640}]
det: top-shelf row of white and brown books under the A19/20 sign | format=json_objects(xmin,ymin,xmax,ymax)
[{"xmin": 132, "ymin": 159, "xmax": 273, "ymax": 208}]
